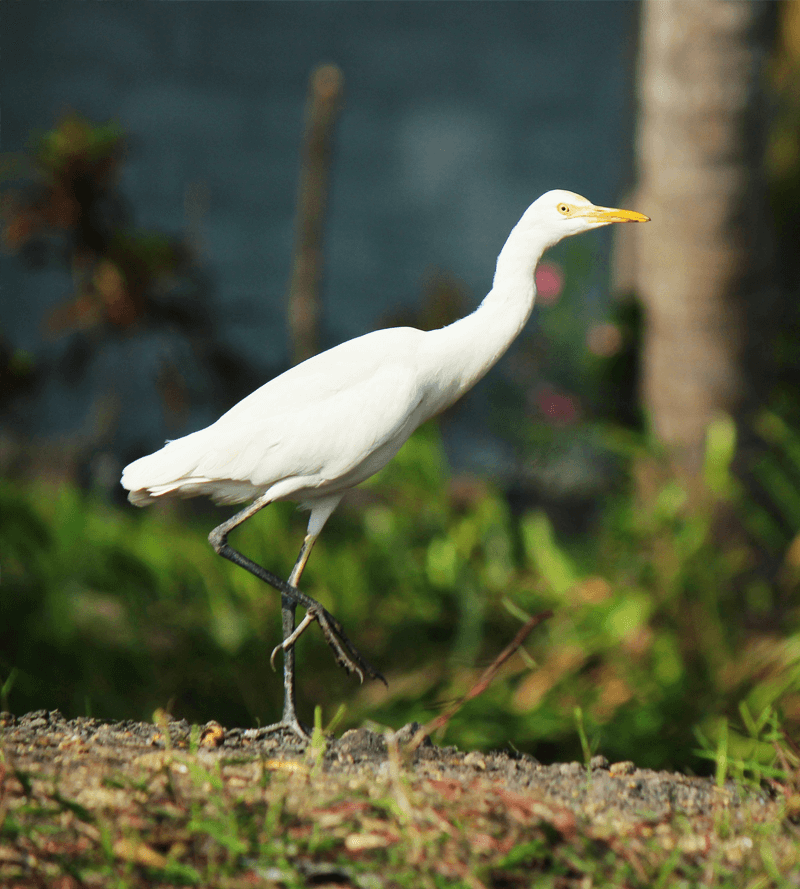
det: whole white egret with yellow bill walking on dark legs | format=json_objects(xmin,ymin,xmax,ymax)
[{"xmin": 122, "ymin": 190, "xmax": 648, "ymax": 737}]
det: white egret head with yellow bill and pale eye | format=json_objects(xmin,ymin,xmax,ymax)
[{"xmin": 520, "ymin": 189, "xmax": 650, "ymax": 247}]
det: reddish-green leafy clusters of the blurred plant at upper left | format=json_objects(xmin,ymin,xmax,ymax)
[{"xmin": 3, "ymin": 113, "xmax": 191, "ymax": 332}]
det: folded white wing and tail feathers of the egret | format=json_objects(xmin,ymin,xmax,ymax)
[{"xmin": 123, "ymin": 328, "xmax": 423, "ymax": 503}]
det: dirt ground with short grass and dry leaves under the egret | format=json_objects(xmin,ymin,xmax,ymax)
[{"xmin": 0, "ymin": 711, "xmax": 800, "ymax": 889}]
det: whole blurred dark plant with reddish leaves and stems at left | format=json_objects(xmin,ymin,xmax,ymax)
[{"xmin": 0, "ymin": 112, "xmax": 262, "ymax": 428}]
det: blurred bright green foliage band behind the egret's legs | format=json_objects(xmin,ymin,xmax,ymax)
[{"xmin": 0, "ymin": 417, "xmax": 800, "ymax": 771}]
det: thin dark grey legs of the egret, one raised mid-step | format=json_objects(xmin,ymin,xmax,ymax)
[{"xmin": 208, "ymin": 497, "xmax": 386, "ymax": 721}]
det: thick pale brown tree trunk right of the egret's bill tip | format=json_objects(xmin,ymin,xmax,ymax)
[{"xmin": 636, "ymin": 0, "xmax": 773, "ymax": 474}]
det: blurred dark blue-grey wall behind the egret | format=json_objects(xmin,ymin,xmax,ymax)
[{"xmin": 0, "ymin": 0, "xmax": 636, "ymax": 464}]
